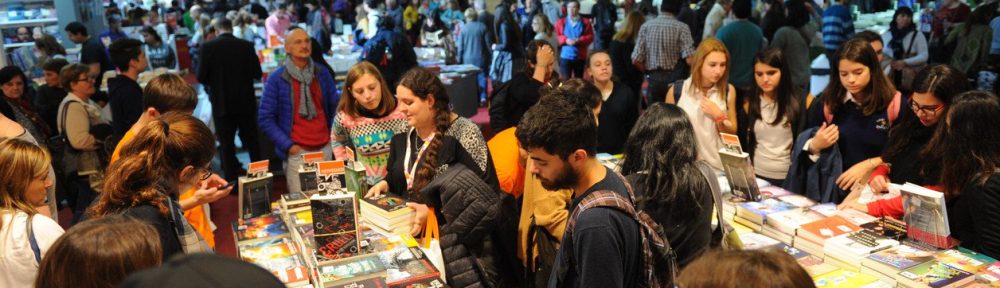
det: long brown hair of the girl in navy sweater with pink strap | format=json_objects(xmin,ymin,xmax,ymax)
[{"xmin": 823, "ymin": 38, "xmax": 896, "ymax": 115}]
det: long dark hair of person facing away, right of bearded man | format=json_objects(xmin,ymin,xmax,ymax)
[{"xmin": 621, "ymin": 102, "xmax": 710, "ymax": 216}]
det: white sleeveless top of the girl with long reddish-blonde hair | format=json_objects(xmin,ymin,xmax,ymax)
[{"xmin": 674, "ymin": 78, "xmax": 728, "ymax": 170}]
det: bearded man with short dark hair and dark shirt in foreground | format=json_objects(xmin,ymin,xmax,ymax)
[{"xmin": 515, "ymin": 82, "xmax": 645, "ymax": 287}]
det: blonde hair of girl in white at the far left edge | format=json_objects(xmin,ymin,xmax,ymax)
[{"xmin": 0, "ymin": 138, "xmax": 51, "ymax": 219}]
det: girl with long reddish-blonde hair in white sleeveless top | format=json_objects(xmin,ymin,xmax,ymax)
[{"xmin": 666, "ymin": 38, "xmax": 736, "ymax": 170}]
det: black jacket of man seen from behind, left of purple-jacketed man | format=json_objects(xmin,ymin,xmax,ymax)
[{"xmin": 198, "ymin": 33, "xmax": 262, "ymax": 117}]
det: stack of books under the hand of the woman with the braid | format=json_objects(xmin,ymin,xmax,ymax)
[{"xmin": 359, "ymin": 194, "xmax": 413, "ymax": 235}]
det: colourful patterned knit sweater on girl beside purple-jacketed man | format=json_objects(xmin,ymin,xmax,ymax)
[{"xmin": 330, "ymin": 105, "xmax": 409, "ymax": 184}]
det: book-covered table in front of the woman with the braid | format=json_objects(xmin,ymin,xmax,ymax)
[{"xmin": 233, "ymin": 192, "xmax": 446, "ymax": 287}]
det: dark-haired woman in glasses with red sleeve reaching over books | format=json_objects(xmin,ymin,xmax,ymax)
[{"xmin": 841, "ymin": 64, "xmax": 969, "ymax": 218}]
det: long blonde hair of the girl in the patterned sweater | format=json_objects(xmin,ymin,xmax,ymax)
[{"xmin": 337, "ymin": 61, "xmax": 396, "ymax": 117}]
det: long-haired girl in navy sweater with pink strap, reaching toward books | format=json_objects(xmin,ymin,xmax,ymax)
[{"xmin": 800, "ymin": 38, "xmax": 902, "ymax": 203}]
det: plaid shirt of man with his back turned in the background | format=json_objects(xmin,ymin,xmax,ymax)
[{"xmin": 632, "ymin": 15, "xmax": 694, "ymax": 70}]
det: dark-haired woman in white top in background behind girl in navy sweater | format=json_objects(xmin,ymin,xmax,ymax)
[{"xmin": 882, "ymin": 7, "xmax": 928, "ymax": 91}]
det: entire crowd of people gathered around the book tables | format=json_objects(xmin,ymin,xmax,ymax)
[{"xmin": 0, "ymin": 0, "xmax": 1000, "ymax": 287}]
